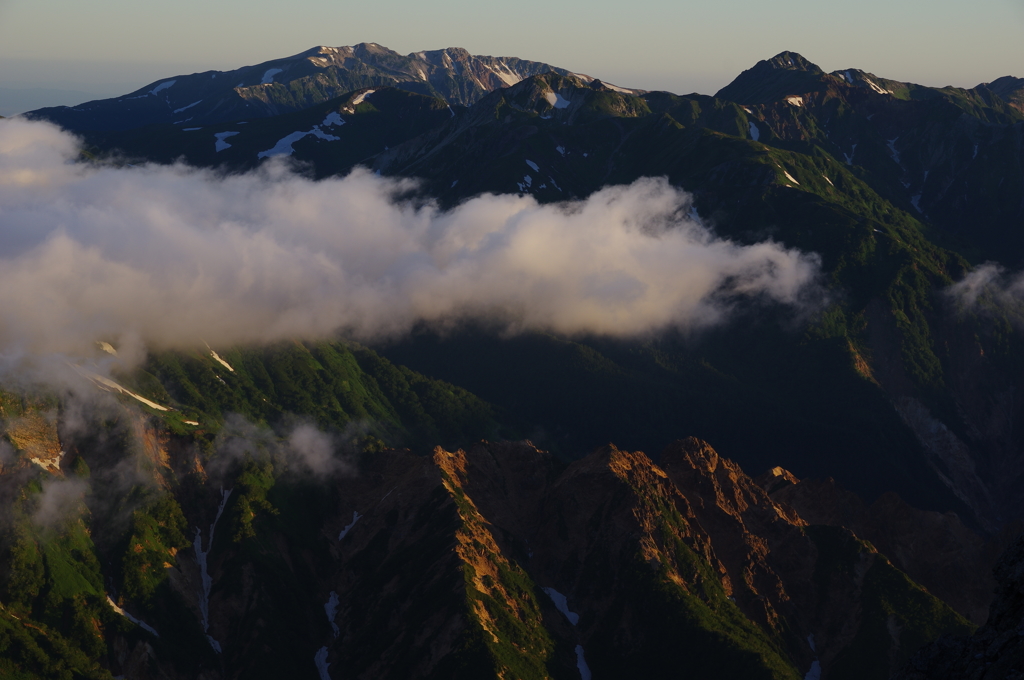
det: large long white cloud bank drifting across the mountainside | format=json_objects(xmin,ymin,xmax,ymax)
[{"xmin": 0, "ymin": 120, "xmax": 819, "ymax": 354}]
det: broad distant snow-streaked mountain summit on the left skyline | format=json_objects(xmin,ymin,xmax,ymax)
[{"xmin": 29, "ymin": 43, "xmax": 638, "ymax": 131}]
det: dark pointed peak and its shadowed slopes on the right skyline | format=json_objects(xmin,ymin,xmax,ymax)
[{"xmin": 716, "ymin": 52, "xmax": 1024, "ymax": 261}]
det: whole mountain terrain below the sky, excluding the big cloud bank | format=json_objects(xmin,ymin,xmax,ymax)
[{"xmin": 0, "ymin": 43, "xmax": 1024, "ymax": 680}]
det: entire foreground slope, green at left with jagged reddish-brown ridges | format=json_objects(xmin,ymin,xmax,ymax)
[{"xmin": 0, "ymin": 383, "xmax": 971, "ymax": 679}]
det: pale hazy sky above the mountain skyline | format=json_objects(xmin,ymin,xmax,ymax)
[{"xmin": 0, "ymin": 0, "xmax": 1024, "ymax": 103}]
